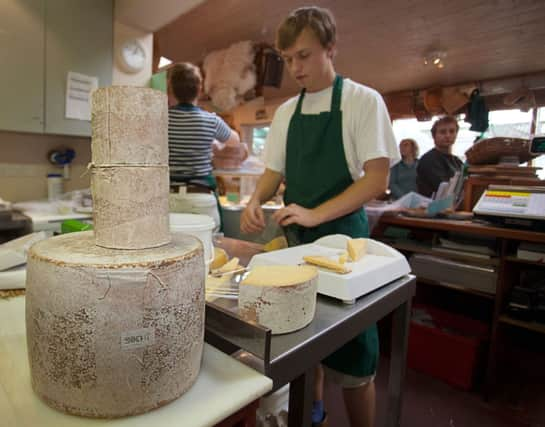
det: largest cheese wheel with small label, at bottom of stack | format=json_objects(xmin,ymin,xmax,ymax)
[{"xmin": 26, "ymin": 231, "xmax": 205, "ymax": 418}]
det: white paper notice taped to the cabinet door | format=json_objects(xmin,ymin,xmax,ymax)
[{"xmin": 66, "ymin": 71, "xmax": 98, "ymax": 120}]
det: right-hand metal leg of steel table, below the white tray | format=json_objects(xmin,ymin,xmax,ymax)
[{"xmin": 384, "ymin": 300, "xmax": 411, "ymax": 427}]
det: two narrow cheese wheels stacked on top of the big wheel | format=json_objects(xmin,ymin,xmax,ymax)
[{"xmin": 91, "ymin": 86, "xmax": 170, "ymax": 249}]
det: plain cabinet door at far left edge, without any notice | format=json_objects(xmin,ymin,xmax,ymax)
[{"xmin": 0, "ymin": 0, "xmax": 44, "ymax": 132}]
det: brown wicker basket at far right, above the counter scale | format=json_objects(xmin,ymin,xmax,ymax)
[{"xmin": 466, "ymin": 137, "xmax": 535, "ymax": 165}]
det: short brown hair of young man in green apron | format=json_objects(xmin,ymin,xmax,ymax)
[{"xmin": 276, "ymin": 6, "xmax": 337, "ymax": 50}]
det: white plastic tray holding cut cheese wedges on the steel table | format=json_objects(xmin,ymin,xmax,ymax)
[{"xmin": 248, "ymin": 234, "xmax": 411, "ymax": 304}]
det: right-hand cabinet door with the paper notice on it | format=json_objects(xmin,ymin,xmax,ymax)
[{"xmin": 45, "ymin": 0, "xmax": 113, "ymax": 136}]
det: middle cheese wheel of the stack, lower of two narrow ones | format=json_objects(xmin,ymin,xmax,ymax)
[{"xmin": 91, "ymin": 166, "xmax": 170, "ymax": 249}]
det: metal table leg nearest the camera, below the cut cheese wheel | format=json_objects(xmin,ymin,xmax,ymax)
[{"xmin": 288, "ymin": 366, "xmax": 316, "ymax": 427}]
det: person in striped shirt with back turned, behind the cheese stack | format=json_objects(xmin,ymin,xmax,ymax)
[{"xmin": 167, "ymin": 62, "xmax": 240, "ymax": 189}]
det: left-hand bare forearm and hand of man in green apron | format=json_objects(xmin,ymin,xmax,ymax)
[{"xmin": 240, "ymin": 169, "xmax": 284, "ymax": 233}]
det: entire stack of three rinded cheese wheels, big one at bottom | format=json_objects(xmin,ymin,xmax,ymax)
[{"xmin": 26, "ymin": 87, "xmax": 205, "ymax": 418}]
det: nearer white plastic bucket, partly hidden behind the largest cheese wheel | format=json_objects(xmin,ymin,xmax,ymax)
[{"xmin": 169, "ymin": 213, "xmax": 215, "ymax": 271}]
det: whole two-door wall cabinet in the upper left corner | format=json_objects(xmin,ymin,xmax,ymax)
[{"xmin": 0, "ymin": 0, "xmax": 113, "ymax": 136}]
